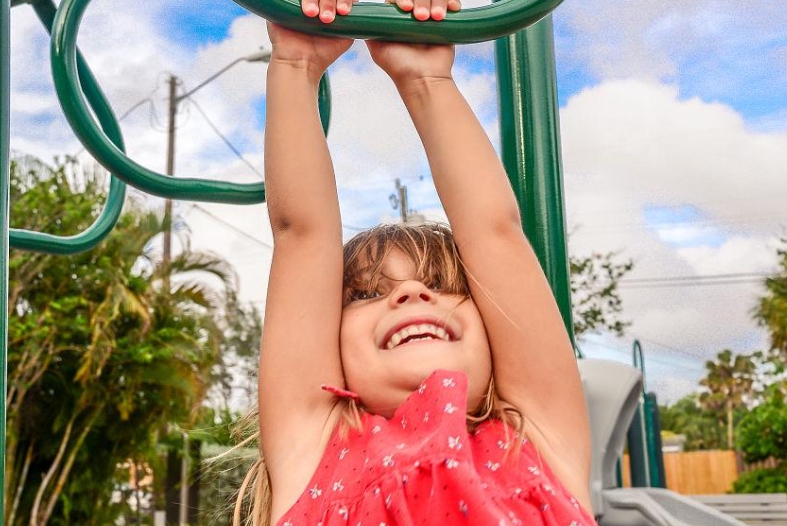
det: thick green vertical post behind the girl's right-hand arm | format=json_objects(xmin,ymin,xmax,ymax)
[{"xmin": 496, "ymin": 15, "xmax": 579, "ymax": 354}]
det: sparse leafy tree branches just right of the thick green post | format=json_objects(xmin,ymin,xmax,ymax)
[{"xmin": 569, "ymin": 252, "xmax": 634, "ymax": 337}]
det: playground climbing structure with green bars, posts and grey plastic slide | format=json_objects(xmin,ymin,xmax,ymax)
[{"xmin": 0, "ymin": 0, "xmax": 741, "ymax": 526}]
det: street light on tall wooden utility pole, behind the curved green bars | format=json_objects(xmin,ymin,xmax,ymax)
[{"xmin": 161, "ymin": 48, "xmax": 271, "ymax": 293}]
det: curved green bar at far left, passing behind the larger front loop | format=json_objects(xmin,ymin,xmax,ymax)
[{"xmin": 10, "ymin": 1, "xmax": 126, "ymax": 254}]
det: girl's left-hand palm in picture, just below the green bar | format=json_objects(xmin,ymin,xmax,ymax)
[{"xmin": 268, "ymin": 23, "xmax": 353, "ymax": 76}]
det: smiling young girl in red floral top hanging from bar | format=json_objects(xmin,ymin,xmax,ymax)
[{"xmin": 242, "ymin": 0, "xmax": 595, "ymax": 526}]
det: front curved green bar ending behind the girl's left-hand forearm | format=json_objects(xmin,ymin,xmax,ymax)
[{"xmin": 52, "ymin": 0, "xmax": 265, "ymax": 204}]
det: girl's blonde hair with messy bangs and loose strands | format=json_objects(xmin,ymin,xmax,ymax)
[{"xmin": 232, "ymin": 223, "xmax": 525, "ymax": 526}]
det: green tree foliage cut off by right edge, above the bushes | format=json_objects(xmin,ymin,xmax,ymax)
[{"xmin": 754, "ymin": 238, "xmax": 787, "ymax": 360}]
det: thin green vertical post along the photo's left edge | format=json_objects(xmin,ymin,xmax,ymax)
[{"xmin": 0, "ymin": 0, "xmax": 11, "ymax": 524}]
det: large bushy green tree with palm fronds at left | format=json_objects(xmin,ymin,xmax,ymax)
[{"xmin": 4, "ymin": 159, "xmax": 240, "ymax": 526}]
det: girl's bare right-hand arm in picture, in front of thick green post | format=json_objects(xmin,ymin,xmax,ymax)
[{"xmin": 369, "ymin": 43, "xmax": 590, "ymax": 508}]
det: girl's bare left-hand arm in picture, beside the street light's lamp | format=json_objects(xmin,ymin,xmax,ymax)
[{"xmin": 259, "ymin": 25, "xmax": 351, "ymax": 519}]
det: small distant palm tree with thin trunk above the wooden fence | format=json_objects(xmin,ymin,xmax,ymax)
[{"xmin": 699, "ymin": 349, "xmax": 757, "ymax": 449}]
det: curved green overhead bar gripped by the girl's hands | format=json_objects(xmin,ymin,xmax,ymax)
[{"xmin": 234, "ymin": 0, "xmax": 563, "ymax": 44}]
